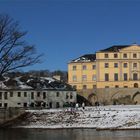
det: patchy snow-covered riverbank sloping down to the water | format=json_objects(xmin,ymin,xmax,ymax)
[{"xmin": 16, "ymin": 105, "xmax": 140, "ymax": 129}]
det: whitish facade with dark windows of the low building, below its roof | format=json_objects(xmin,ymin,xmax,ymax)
[{"xmin": 0, "ymin": 89, "xmax": 76, "ymax": 108}]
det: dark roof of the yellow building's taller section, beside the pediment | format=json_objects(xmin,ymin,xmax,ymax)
[{"xmin": 99, "ymin": 45, "xmax": 131, "ymax": 52}]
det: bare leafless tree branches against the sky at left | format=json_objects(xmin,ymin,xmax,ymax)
[{"xmin": 0, "ymin": 15, "xmax": 41, "ymax": 76}]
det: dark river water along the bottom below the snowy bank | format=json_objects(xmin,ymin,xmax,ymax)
[{"xmin": 0, "ymin": 129, "xmax": 140, "ymax": 140}]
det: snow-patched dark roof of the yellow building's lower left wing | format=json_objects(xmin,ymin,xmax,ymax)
[{"xmin": 71, "ymin": 54, "xmax": 96, "ymax": 62}]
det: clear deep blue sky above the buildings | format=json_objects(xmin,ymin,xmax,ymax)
[{"xmin": 0, "ymin": 0, "xmax": 140, "ymax": 70}]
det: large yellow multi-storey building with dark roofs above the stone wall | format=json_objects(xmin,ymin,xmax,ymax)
[{"xmin": 68, "ymin": 44, "xmax": 140, "ymax": 90}]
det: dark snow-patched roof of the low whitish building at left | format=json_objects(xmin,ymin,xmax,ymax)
[{"xmin": 0, "ymin": 76, "xmax": 74, "ymax": 91}]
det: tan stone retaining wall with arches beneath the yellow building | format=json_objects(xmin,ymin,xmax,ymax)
[{"xmin": 78, "ymin": 88, "xmax": 140, "ymax": 105}]
